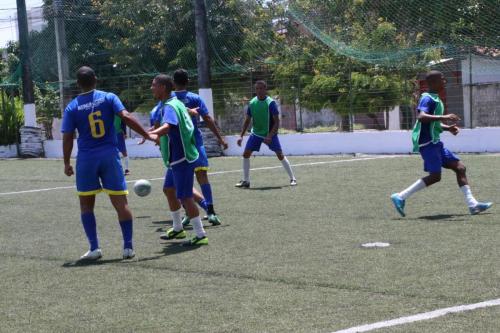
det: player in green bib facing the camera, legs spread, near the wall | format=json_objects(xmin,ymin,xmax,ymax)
[{"xmin": 236, "ymin": 81, "xmax": 297, "ymax": 188}]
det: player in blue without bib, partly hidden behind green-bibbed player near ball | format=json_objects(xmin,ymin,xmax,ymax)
[{"xmin": 174, "ymin": 69, "xmax": 228, "ymax": 225}]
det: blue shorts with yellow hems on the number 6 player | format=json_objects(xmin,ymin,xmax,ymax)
[{"xmin": 76, "ymin": 152, "xmax": 128, "ymax": 196}]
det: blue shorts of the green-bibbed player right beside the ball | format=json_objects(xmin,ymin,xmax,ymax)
[{"xmin": 163, "ymin": 161, "xmax": 197, "ymax": 200}]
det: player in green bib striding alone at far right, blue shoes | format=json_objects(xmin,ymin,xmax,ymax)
[{"xmin": 391, "ymin": 71, "xmax": 492, "ymax": 216}]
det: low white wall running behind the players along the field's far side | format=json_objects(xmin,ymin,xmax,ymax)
[{"xmin": 45, "ymin": 127, "xmax": 500, "ymax": 158}]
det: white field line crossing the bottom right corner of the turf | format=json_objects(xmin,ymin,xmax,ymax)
[{"xmin": 332, "ymin": 298, "xmax": 500, "ymax": 333}]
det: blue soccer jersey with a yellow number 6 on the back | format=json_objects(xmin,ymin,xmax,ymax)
[{"xmin": 61, "ymin": 90, "xmax": 125, "ymax": 160}]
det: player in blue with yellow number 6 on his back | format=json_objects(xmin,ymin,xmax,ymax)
[{"xmin": 61, "ymin": 67, "xmax": 152, "ymax": 260}]
